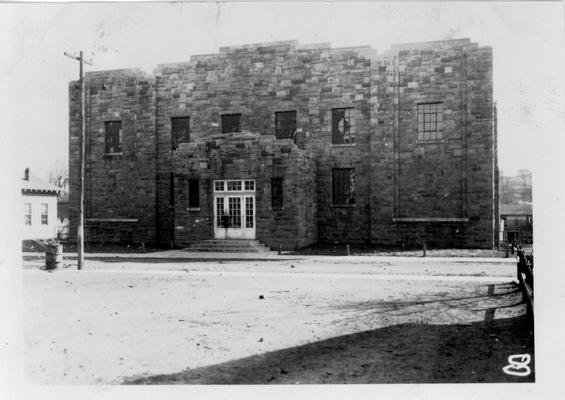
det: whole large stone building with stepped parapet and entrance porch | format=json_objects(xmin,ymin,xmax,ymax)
[{"xmin": 69, "ymin": 39, "xmax": 498, "ymax": 249}]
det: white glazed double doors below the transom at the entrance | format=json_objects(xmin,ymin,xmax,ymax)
[{"xmin": 214, "ymin": 194, "xmax": 255, "ymax": 239}]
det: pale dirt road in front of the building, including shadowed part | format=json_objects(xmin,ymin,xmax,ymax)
[{"xmin": 23, "ymin": 255, "xmax": 533, "ymax": 384}]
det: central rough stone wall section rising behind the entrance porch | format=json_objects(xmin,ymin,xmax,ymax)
[{"xmin": 157, "ymin": 42, "xmax": 371, "ymax": 242}]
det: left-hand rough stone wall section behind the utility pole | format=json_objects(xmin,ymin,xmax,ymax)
[{"xmin": 69, "ymin": 70, "xmax": 156, "ymax": 243}]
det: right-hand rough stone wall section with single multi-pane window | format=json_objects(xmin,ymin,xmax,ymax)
[{"xmin": 371, "ymin": 39, "xmax": 493, "ymax": 247}]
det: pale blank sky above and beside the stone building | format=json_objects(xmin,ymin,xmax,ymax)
[{"xmin": 0, "ymin": 1, "xmax": 565, "ymax": 178}]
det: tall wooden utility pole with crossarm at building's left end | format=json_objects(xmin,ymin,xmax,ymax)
[{"xmin": 65, "ymin": 50, "xmax": 92, "ymax": 270}]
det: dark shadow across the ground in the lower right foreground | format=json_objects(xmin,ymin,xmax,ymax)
[{"xmin": 124, "ymin": 315, "xmax": 535, "ymax": 384}]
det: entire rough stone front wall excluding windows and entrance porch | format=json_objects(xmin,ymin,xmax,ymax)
[{"xmin": 69, "ymin": 39, "xmax": 494, "ymax": 247}]
